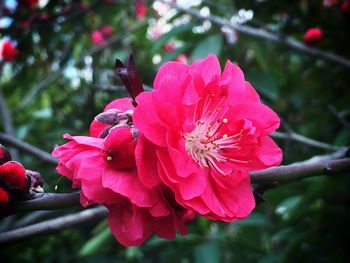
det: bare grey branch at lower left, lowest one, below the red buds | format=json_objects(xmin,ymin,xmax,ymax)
[{"xmin": 0, "ymin": 207, "xmax": 108, "ymax": 245}]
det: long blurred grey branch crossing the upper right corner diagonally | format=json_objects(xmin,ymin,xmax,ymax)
[{"xmin": 160, "ymin": 0, "xmax": 350, "ymax": 67}]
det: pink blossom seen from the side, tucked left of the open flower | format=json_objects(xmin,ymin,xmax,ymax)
[{"xmin": 52, "ymin": 98, "xmax": 187, "ymax": 246}]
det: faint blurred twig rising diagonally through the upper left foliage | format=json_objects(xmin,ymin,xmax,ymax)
[{"xmin": 16, "ymin": 23, "xmax": 145, "ymax": 111}]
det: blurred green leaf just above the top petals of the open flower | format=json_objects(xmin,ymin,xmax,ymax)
[{"xmin": 191, "ymin": 34, "xmax": 222, "ymax": 61}]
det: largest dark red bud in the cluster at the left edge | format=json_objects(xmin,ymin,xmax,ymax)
[{"xmin": 0, "ymin": 161, "xmax": 28, "ymax": 192}]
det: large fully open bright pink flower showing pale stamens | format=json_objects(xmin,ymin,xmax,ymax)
[{"xmin": 133, "ymin": 55, "xmax": 282, "ymax": 222}]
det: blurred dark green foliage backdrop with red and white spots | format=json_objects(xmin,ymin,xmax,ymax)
[{"xmin": 0, "ymin": 0, "xmax": 350, "ymax": 263}]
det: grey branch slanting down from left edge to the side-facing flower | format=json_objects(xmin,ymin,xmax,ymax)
[{"xmin": 0, "ymin": 132, "xmax": 58, "ymax": 165}]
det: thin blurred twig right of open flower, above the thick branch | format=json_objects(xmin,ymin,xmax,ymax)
[{"xmin": 271, "ymin": 132, "xmax": 346, "ymax": 151}]
